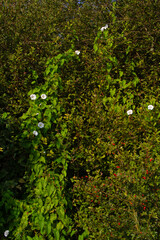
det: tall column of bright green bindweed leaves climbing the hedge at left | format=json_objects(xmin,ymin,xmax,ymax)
[{"xmin": 9, "ymin": 51, "xmax": 80, "ymax": 240}]
